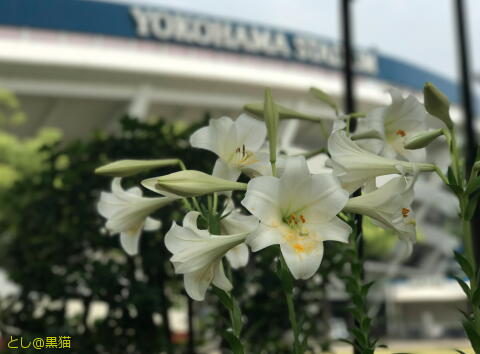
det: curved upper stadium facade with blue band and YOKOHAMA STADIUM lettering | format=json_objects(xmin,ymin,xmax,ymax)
[{"xmin": 0, "ymin": 0, "xmax": 458, "ymax": 145}]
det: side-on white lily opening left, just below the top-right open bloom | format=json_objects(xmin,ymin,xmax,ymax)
[{"xmin": 328, "ymin": 130, "xmax": 433, "ymax": 192}]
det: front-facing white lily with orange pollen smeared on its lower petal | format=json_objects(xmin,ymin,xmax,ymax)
[{"xmin": 242, "ymin": 157, "xmax": 351, "ymax": 279}]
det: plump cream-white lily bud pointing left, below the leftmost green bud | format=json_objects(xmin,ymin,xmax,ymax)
[{"xmin": 142, "ymin": 170, "xmax": 247, "ymax": 197}]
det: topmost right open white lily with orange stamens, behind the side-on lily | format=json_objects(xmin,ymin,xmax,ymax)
[{"xmin": 355, "ymin": 89, "xmax": 428, "ymax": 162}]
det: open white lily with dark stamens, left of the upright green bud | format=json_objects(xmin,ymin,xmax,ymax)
[{"xmin": 190, "ymin": 114, "xmax": 268, "ymax": 181}]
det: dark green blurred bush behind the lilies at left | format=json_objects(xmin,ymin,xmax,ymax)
[{"xmin": 0, "ymin": 117, "xmax": 352, "ymax": 354}]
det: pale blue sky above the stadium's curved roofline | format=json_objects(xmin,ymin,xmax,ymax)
[{"xmin": 95, "ymin": 0, "xmax": 480, "ymax": 83}]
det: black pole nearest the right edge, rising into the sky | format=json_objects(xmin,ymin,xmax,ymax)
[{"xmin": 455, "ymin": 0, "xmax": 480, "ymax": 266}]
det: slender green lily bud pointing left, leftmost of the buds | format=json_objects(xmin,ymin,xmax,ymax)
[{"xmin": 95, "ymin": 159, "xmax": 178, "ymax": 177}]
